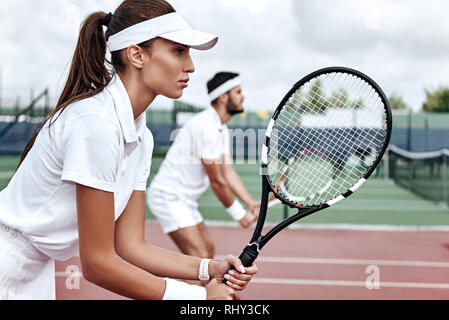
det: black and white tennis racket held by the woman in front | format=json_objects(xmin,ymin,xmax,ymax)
[{"xmin": 236, "ymin": 67, "xmax": 392, "ymax": 267}]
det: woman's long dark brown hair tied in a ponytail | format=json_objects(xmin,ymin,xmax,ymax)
[{"xmin": 17, "ymin": 0, "xmax": 175, "ymax": 168}]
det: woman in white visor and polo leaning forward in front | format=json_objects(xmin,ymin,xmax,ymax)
[{"xmin": 0, "ymin": 0, "xmax": 257, "ymax": 300}]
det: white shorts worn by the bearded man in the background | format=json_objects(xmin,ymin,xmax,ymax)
[{"xmin": 147, "ymin": 186, "xmax": 204, "ymax": 233}]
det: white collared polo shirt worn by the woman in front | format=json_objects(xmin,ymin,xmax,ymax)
[{"xmin": 0, "ymin": 76, "xmax": 153, "ymax": 260}]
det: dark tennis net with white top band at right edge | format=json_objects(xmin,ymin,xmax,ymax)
[{"xmin": 388, "ymin": 146, "xmax": 449, "ymax": 206}]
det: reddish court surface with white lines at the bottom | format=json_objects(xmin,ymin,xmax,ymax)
[{"xmin": 56, "ymin": 224, "xmax": 449, "ymax": 300}]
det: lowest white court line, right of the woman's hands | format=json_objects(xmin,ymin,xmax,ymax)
[{"xmin": 251, "ymin": 277, "xmax": 449, "ymax": 291}]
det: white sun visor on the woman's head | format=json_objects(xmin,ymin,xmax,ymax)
[{"xmin": 107, "ymin": 12, "xmax": 218, "ymax": 52}]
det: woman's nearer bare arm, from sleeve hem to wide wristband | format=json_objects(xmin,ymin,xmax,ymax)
[{"xmin": 76, "ymin": 185, "xmax": 165, "ymax": 299}]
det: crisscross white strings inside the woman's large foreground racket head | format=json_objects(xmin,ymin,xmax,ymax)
[{"xmin": 268, "ymin": 73, "xmax": 385, "ymax": 205}]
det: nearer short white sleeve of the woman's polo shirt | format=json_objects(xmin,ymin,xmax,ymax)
[{"xmin": 62, "ymin": 115, "xmax": 120, "ymax": 192}]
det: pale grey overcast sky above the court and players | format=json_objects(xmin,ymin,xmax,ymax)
[{"xmin": 0, "ymin": 0, "xmax": 449, "ymax": 110}]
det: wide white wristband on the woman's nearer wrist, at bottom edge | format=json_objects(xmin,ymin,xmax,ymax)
[{"xmin": 162, "ymin": 278, "xmax": 207, "ymax": 300}]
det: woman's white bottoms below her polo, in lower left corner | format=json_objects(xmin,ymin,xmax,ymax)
[{"xmin": 0, "ymin": 223, "xmax": 56, "ymax": 300}]
